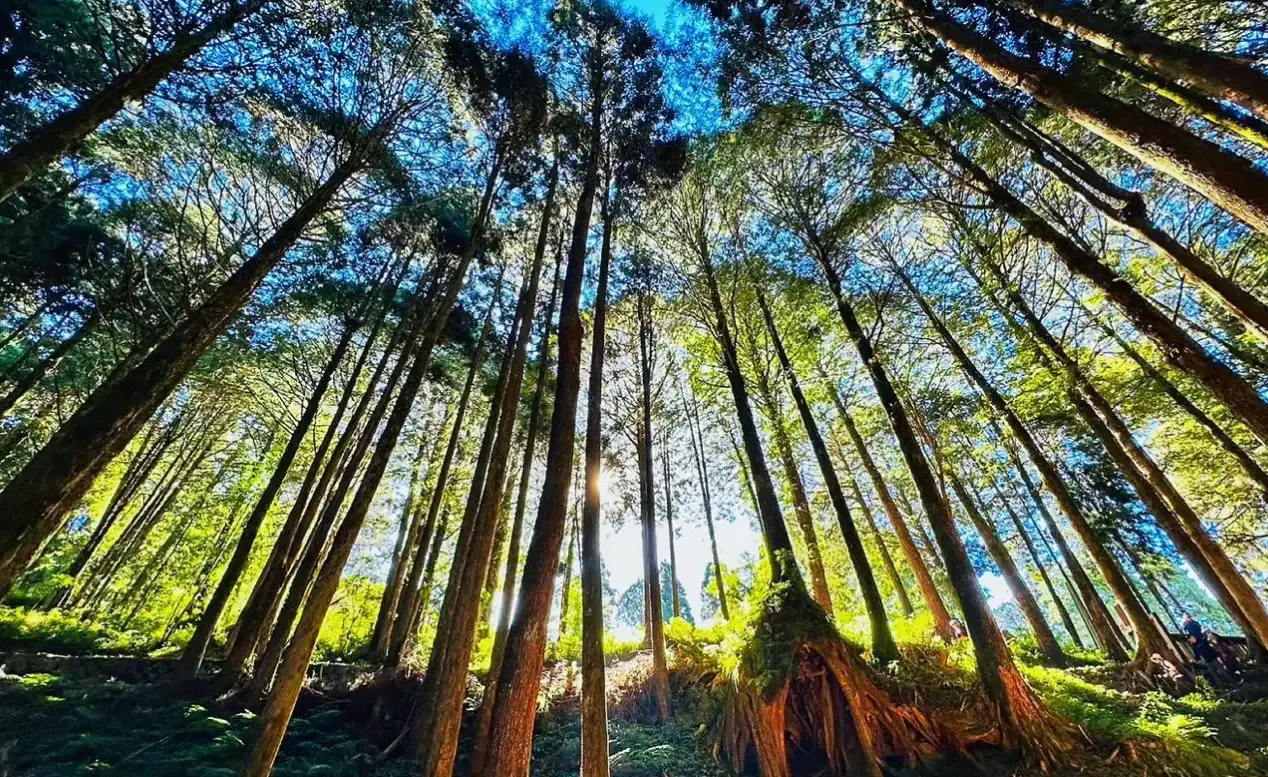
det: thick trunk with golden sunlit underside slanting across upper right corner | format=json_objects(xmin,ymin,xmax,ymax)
[{"xmin": 891, "ymin": 0, "xmax": 1268, "ymax": 234}]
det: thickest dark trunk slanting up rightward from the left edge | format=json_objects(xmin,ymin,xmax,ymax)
[{"xmin": 0, "ymin": 143, "xmax": 372, "ymax": 597}]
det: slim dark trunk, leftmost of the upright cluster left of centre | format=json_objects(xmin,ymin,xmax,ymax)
[{"xmin": 178, "ymin": 311, "xmax": 359, "ymax": 677}]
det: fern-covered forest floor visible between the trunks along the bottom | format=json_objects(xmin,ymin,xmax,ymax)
[{"xmin": 0, "ymin": 641, "xmax": 1268, "ymax": 777}]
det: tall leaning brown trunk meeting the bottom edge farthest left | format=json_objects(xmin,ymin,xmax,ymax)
[{"xmin": 243, "ymin": 140, "xmax": 489, "ymax": 777}]
